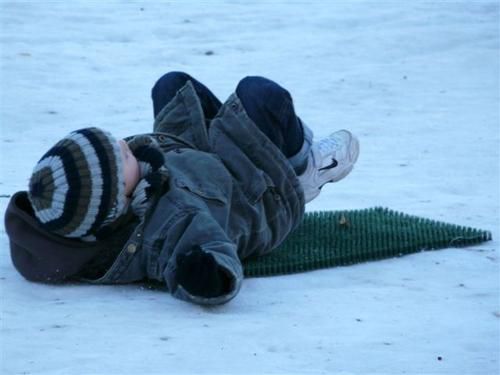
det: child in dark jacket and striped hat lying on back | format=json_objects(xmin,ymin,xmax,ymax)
[{"xmin": 5, "ymin": 72, "xmax": 359, "ymax": 304}]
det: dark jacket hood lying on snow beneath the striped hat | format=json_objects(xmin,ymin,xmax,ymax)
[{"xmin": 5, "ymin": 191, "xmax": 103, "ymax": 283}]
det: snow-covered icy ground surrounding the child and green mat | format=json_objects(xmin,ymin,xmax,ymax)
[{"xmin": 0, "ymin": 0, "xmax": 500, "ymax": 374}]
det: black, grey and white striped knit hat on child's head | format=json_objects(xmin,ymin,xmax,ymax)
[{"xmin": 28, "ymin": 128, "xmax": 126, "ymax": 240}]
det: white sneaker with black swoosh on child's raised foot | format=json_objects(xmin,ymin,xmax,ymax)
[{"xmin": 298, "ymin": 130, "xmax": 359, "ymax": 203}]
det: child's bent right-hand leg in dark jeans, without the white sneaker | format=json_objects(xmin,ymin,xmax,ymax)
[{"xmin": 236, "ymin": 77, "xmax": 312, "ymax": 174}]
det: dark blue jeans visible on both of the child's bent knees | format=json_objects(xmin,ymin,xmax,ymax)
[{"xmin": 151, "ymin": 72, "xmax": 304, "ymax": 158}]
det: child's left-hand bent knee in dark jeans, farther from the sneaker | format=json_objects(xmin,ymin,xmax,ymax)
[{"xmin": 151, "ymin": 72, "xmax": 222, "ymax": 119}]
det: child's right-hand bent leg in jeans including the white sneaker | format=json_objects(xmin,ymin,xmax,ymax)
[{"xmin": 236, "ymin": 77, "xmax": 359, "ymax": 202}]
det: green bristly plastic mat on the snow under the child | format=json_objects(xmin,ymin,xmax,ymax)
[{"xmin": 244, "ymin": 207, "xmax": 491, "ymax": 277}]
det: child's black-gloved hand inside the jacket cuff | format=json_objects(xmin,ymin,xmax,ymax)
[{"xmin": 176, "ymin": 247, "xmax": 231, "ymax": 298}]
